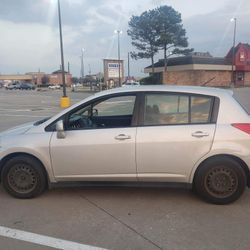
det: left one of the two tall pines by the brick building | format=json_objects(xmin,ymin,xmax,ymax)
[{"xmin": 127, "ymin": 11, "xmax": 159, "ymax": 73}]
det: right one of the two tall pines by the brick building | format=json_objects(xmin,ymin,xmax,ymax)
[{"xmin": 152, "ymin": 5, "xmax": 193, "ymax": 71}]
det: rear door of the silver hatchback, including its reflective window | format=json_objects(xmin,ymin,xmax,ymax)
[{"xmin": 136, "ymin": 93, "xmax": 215, "ymax": 182}]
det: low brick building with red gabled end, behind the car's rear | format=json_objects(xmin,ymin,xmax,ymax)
[{"xmin": 144, "ymin": 43, "xmax": 250, "ymax": 87}]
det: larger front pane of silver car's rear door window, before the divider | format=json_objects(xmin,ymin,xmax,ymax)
[{"xmin": 144, "ymin": 94, "xmax": 189, "ymax": 125}]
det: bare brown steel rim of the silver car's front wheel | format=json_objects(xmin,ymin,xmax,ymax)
[{"xmin": 8, "ymin": 164, "xmax": 38, "ymax": 194}]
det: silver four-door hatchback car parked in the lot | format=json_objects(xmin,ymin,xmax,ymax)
[{"xmin": 0, "ymin": 86, "xmax": 250, "ymax": 204}]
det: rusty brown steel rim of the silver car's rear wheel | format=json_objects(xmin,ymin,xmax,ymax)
[{"xmin": 205, "ymin": 166, "xmax": 238, "ymax": 198}]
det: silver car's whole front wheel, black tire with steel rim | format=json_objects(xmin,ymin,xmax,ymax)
[{"xmin": 1, "ymin": 156, "xmax": 47, "ymax": 199}]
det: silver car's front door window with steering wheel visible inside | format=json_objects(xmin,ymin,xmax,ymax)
[{"xmin": 66, "ymin": 95, "xmax": 136, "ymax": 130}]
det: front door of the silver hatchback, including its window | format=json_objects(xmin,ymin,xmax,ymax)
[{"xmin": 50, "ymin": 94, "xmax": 136, "ymax": 181}]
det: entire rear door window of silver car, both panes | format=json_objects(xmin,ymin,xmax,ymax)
[{"xmin": 143, "ymin": 93, "xmax": 213, "ymax": 125}]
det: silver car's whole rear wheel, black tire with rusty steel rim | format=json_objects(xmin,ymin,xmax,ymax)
[{"xmin": 194, "ymin": 157, "xmax": 247, "ymax": 205}]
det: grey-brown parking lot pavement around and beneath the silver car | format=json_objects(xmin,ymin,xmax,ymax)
[{"xmin": 0, "ymin": 89, "xmax": 250, "ymax": 250}]
